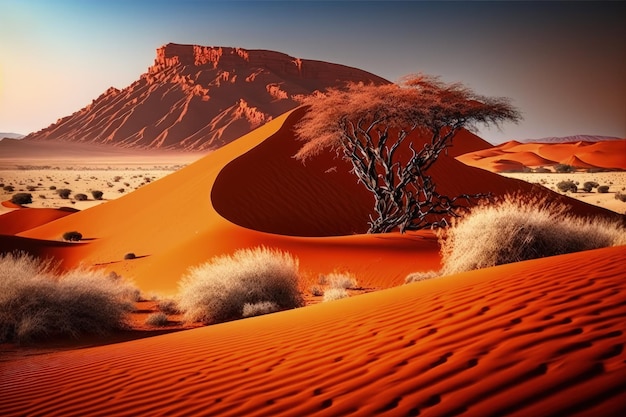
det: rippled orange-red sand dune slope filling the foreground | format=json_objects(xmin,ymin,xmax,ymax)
[{"xmin": 0, "ymin": 247, "xmax": 626, "ymax": 416}]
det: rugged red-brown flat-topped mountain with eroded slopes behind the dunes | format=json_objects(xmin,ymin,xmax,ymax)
[{"xmin": 26, "ymin": 43, "xmax": 388, "ymax": 150}]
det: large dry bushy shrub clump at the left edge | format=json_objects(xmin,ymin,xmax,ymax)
[{"xmin": 0, "ymin": 254, "xmax": 137, "ymax": 343}]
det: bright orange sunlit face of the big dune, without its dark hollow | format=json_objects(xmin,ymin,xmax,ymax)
[{"xmin": 13, "ymin": 110, "xmax": 439, "ymax": 292}]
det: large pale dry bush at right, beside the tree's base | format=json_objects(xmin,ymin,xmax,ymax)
[{"xmin": 440, "ymin": 196, "xmax": 626, "ymax": 275}]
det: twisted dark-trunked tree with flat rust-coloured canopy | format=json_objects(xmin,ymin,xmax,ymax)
[{"xmin": 296, "ymin": 75, "xmax": 521, "ymax": 233}]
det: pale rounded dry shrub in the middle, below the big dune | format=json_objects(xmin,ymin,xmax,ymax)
[{"xmin": 178, "ymin": 247, "xmax": 304, "ymax": 324}]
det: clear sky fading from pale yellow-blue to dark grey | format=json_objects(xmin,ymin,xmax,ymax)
[{"xmin": 0, "ymin": 0, "xmax": 626, "ymax": 143}]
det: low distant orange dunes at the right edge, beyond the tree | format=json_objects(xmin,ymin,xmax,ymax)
[{"xmin": 458, "ymin": 140, "xmax": 626, "ymax": 172}]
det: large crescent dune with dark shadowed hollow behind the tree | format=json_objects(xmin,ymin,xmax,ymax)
[{"xmin": 0, "ymin": 109, "xmax": 615, "ymax": 293}]
